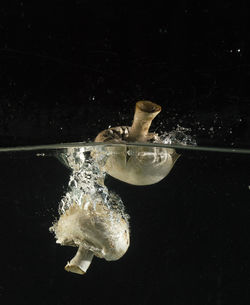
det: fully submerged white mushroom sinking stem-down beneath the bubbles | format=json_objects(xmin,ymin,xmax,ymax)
[{"xmin": 51, "ymin": 195, "xmax": 130, "ymax": 274}]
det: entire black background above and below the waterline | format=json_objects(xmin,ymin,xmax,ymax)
[{"xmin": 0, "ymin": 0, "xmax": 250, "ymax": 305}]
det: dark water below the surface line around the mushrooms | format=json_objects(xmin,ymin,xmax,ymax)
[{"xmin": 0, "ymin": 143, "xmax": 250, "ymax": 305}]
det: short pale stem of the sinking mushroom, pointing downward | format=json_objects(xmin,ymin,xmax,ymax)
[{"xmin": 65, "ymin": 246, "xmax": 94, "ymax": 274}]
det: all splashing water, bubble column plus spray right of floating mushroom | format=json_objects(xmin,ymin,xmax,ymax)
[{"xmin": 56, "ymin": 125, "xmax": 196, "ymax": 220}]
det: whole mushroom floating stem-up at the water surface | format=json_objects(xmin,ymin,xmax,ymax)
[{"xmin": 92, "ymin": 101, "xmax": 180, "ymax": 185}]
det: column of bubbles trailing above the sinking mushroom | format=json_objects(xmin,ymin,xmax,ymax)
[{"xmin": 56, "ymin": 147, "xmax": 129, "ymax": 221}]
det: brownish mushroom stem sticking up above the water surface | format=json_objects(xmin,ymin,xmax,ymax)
[{"xmin": 128, "ymin": 101, "xmax": 161, "ymax": 142}]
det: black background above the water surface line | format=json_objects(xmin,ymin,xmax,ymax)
[{"xmin": 0, "ymin": 0, "xmax": 250, "ymax": 146}]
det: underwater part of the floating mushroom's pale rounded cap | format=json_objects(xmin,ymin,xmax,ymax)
[{"xmin": 93, "ymin": 145, "xmax": 179, "ymax": 185}]
